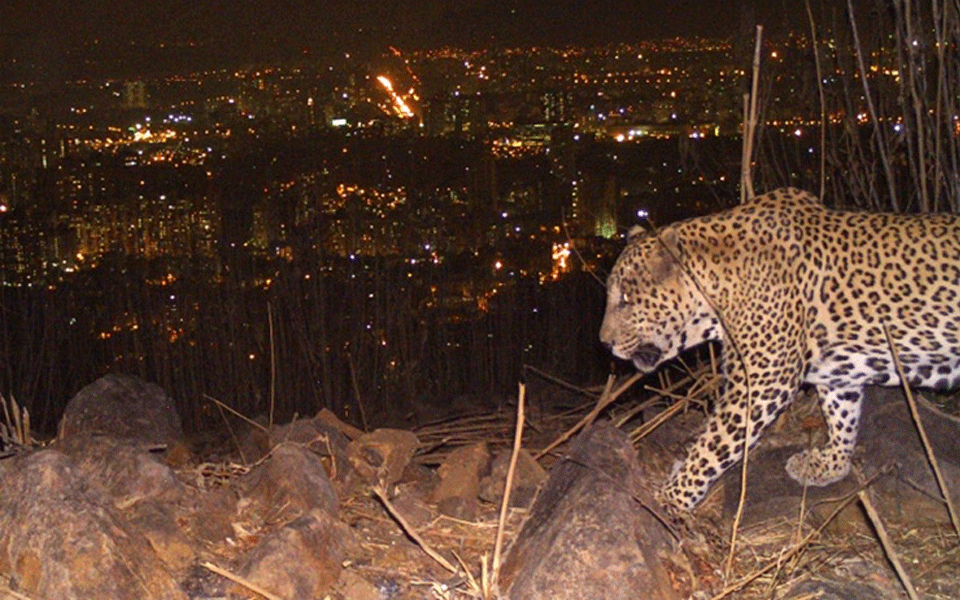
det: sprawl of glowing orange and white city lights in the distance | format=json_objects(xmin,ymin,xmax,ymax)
[{"xmin": 0, "ymin": 33, "xmax": 900, "ymax": 298}]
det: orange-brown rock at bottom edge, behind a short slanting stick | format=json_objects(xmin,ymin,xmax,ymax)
[{"xmin": 241, "ymin": 510, "xmax": 351, "ymax": 600}]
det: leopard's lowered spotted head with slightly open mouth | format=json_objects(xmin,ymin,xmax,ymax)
[{"xmin": 600, "ymin": 227, "xmax": 704, "ymax": 373}]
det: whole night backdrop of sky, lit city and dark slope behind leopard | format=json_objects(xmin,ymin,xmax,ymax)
[{"xmin": 0, "ymin": 1, "xmax": 928, "ymax": 434}]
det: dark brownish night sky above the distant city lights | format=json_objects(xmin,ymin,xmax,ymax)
[{"xmin": 0, "ymin": 0, "xmax": 840, "ymax": 76}]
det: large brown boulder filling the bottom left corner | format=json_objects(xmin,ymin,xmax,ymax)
[{"xmin": 0, "ymin": 450, "xmax": 187, "ymax": 600}]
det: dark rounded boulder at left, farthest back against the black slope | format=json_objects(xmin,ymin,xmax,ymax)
[{"xmin": 58, "ymin": 374, "xmax": 183, "ymax": 447}]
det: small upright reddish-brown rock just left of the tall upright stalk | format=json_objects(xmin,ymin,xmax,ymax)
[{"xmin": 431, "ymin": 442, "xmax": 490, "ymax": 521}]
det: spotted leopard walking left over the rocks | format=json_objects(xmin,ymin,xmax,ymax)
[{"xmin": 600, "ymin": 188, "xmax": 960, "ymax": 510}]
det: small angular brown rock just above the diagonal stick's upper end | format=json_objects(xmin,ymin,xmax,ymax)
[{"xmin": 347, "ymin": 429, "xmax": 420, "ymax": 488}]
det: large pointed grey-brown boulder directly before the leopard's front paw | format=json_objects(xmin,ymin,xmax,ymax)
[{"xmin": 500, "ymin": 423, "xmax": 679, "ymax": 600}]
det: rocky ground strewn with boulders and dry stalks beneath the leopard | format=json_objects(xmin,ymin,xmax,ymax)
[{"xmin": 0, "ymin": 375, "xmax": 960, "ymax": 600}]
